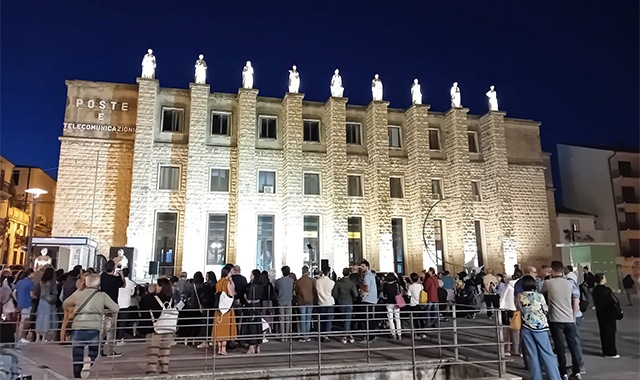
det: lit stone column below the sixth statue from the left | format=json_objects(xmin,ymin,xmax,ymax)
[{"xmin": 364, "ymin": 100, "xmax": 394, "ymax": 272}]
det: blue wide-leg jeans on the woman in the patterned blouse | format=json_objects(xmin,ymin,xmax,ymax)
[{"xmin": 520, "ymin": 328, "xmax": 561, "ymax": 380}]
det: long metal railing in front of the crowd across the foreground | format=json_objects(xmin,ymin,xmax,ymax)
[{"xmin": 0, "ymin": 304, "xmax": 507, "ymax": 379}]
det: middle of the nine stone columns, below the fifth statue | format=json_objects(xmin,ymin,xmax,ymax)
[{"xmin": 323, "ymin": 97, "xmax": 350, "ymax": 273}]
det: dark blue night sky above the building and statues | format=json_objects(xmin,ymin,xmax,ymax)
[{"xmin": 0, "ymin": 0, "xmax": 640, "ymax": 205}]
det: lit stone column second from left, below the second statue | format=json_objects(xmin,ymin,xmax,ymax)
[{"xmin": 182, "ymin": 83, "xmax": 210, "ymax": 275}]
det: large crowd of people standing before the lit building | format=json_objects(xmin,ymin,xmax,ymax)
[{"xmin": 0, "ymin": 260, "xmax": 622, "ymax": 380}]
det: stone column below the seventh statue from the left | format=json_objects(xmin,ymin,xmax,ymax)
[{"xmin": 404, "ymin": 104, "xmax": 437, "ymax": 273}]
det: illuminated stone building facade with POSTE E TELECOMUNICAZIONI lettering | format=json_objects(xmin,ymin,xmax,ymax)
[{"xmin": 53, "ymin": 78, "xmax": 555, "ymax": 278}]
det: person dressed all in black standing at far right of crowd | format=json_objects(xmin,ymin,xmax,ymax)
[{"xmin": 592, "ymin": 273, "xmax": 623, "ymax": 359}]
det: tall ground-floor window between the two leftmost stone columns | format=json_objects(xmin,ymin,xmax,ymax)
[{"xmin": 154, "ymin": 212, "xmax": 178, "ymax": 276}]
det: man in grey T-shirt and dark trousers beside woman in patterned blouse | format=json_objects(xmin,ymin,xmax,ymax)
[{"xmin": 542, "ymin": 261, "xmax": 582, "ymax": 380}]
